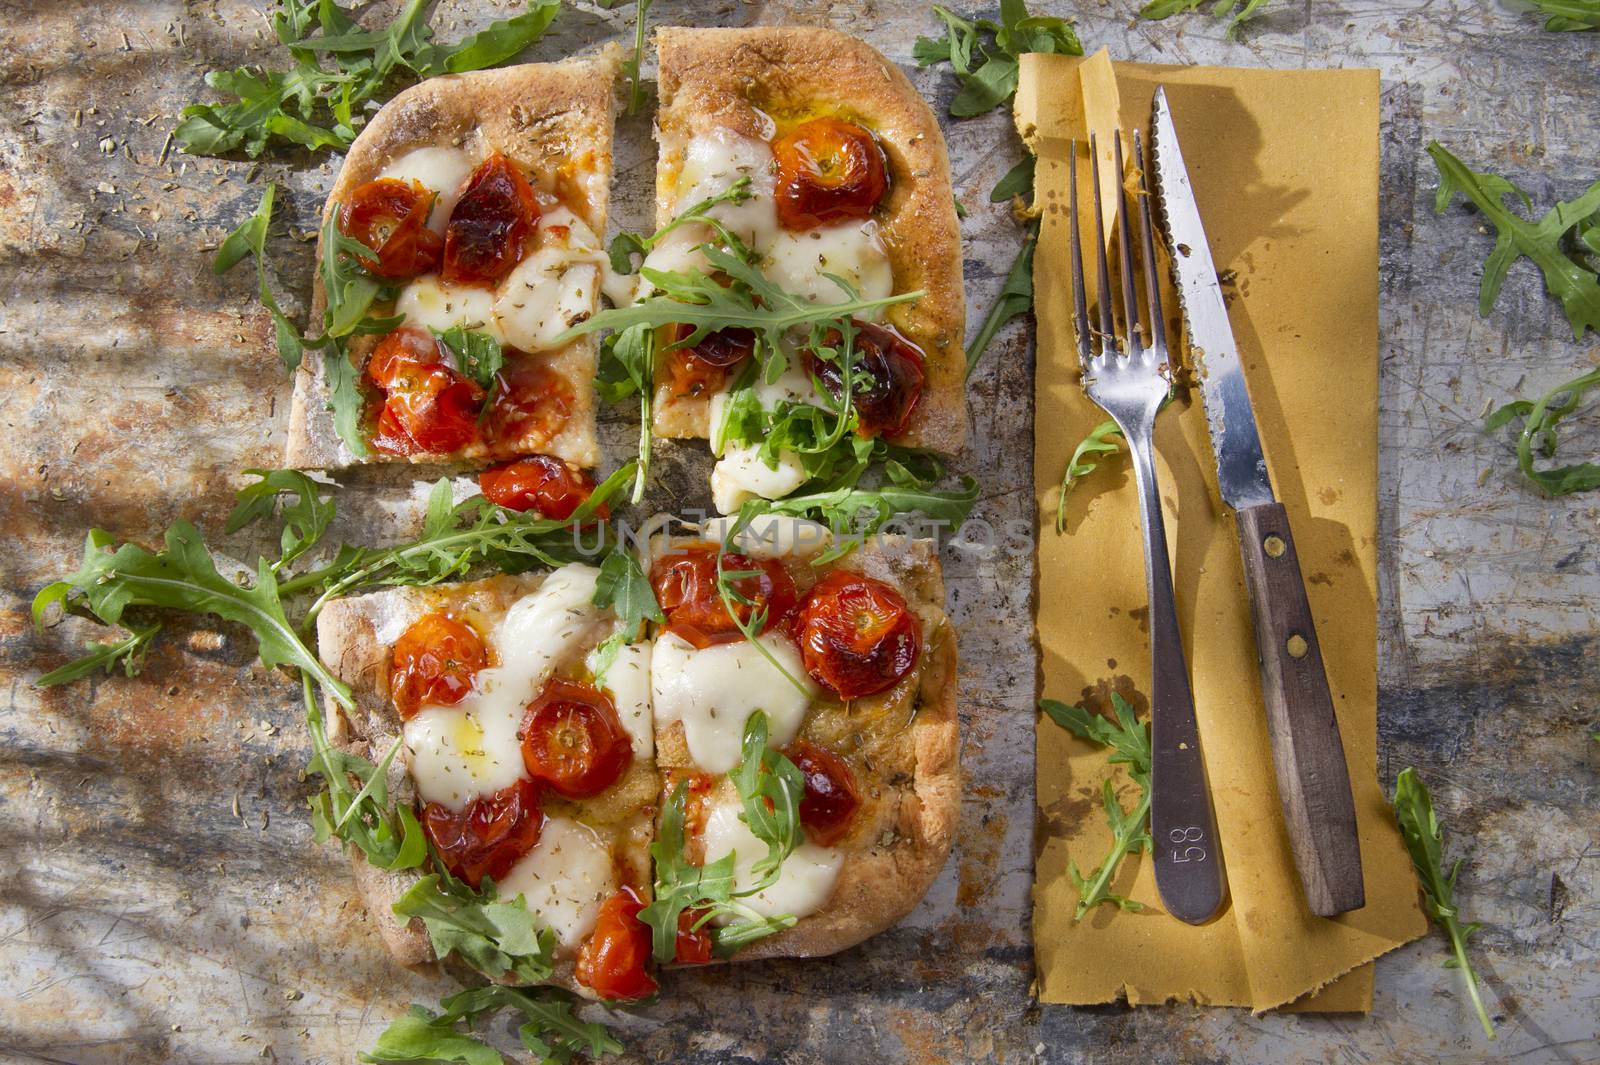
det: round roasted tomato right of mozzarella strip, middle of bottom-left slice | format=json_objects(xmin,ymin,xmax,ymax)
[{"xmin": 517, "ymin": 678, "xmax": 634, "ymax": 798}]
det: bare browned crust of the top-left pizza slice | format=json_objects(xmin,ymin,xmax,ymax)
[{"xmin": 285, "ymin": 45, "xmax": 621, "ymax": 470}]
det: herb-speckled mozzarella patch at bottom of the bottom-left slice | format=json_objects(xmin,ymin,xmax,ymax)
[{"xmin": 494, "ymin": 817, "xmax": 616, "ymax": 953}]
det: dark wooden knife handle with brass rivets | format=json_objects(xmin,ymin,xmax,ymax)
[{"xmin": 1238, "ymin": 502, "xmax": 1366, "ymax": 916}]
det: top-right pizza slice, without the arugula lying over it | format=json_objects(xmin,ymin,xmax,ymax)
[{"xmin": 642, "ymin": 27, "xmax": 966, "ymax": 513}]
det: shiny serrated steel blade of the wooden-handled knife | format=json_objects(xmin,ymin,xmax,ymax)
[{"xmin": 1150, "ymin": 88, "xmax": 1275, "ymax": 510}]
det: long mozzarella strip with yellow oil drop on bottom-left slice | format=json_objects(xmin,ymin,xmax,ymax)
[{"xmin": 405, "ymin": 564, "xmax": 606, "ymax": 809}]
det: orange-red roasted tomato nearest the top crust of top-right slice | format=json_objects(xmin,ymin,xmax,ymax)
[{"xmin": 773, "ymin": 118, "xmax": 890, "ymax": 230}]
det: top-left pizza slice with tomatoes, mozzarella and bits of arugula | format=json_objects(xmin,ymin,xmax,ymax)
[{"xmin": 286, "ymin": 46, "xmax": 619, "ymax": 469}]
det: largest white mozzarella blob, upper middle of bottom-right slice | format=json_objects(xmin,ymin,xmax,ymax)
[{"xmin": 650, "ymin": 632, "xmax": 816, "ymax": 772}]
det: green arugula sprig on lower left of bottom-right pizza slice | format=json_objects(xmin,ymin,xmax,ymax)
[{"xmin": 638, "ymin": 710, "xmax": 805, "ymax": 964}]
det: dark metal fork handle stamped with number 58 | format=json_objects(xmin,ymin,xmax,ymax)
[{"xmin": 1128, "ymin": 437, "xmax": 1224, "ymax": 924}]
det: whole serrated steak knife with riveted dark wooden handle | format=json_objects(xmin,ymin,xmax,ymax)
[{"xmin": 1150, "ymin": 88, "xmax": 1366, "ymax": 916}]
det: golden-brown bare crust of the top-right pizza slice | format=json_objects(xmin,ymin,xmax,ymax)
[{"xmin": 654, "ymin": 26, "xmax": 966, "ymax": 453}]
